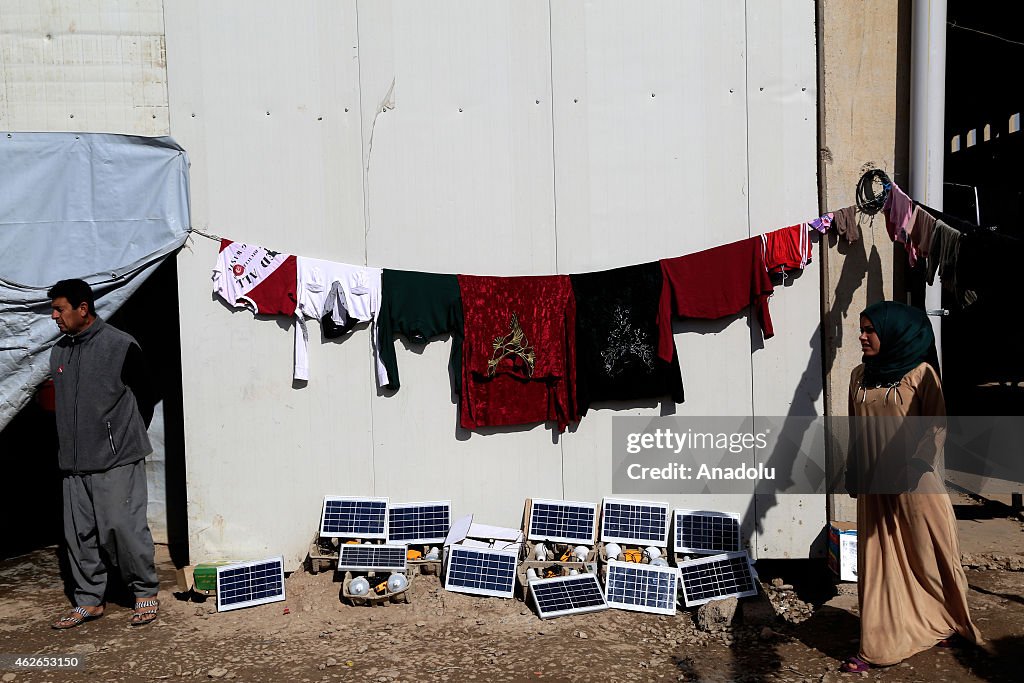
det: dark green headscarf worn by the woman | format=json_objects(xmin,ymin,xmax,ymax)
[{"xmin": 861, "ymin": 301, "xmax": 935, "ymax": 386}]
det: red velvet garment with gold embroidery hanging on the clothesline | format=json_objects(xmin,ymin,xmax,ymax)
[{"xmin": 459, "ymin": 275, "xmax": 580, "ymax": 431}]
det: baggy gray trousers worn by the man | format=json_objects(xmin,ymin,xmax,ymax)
[{"xmin": 63, "ymin": 460, "xmax": 160, "ymax": 606}]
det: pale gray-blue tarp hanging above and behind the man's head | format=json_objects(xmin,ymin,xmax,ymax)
[{"xmin": 0, "ymin": 133, "xmax": 189, "ymax": 429}]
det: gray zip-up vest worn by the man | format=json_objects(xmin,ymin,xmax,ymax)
[{"xmin": 50, "ymin": 317, "xmax": 153, "ymax": 473}]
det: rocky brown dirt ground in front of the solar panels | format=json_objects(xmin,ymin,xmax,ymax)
[{"xmin": 0, "ymin": 497, "xmax": 1024, "ymax": 683}]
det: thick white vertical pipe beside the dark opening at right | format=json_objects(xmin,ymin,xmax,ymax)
[{"xmin": 910, "ymin": 0, "xmax": 946, "ymax": 366}]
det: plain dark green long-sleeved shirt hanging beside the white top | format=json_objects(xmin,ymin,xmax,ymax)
[{"xmin": 377, "ymin": 268, "xmax": 464, "ymax": 393}]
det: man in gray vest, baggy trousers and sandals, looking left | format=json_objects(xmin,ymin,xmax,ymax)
[{"xmin": 46, "ymin": 280, "xmax": 160, "ymax": 629}]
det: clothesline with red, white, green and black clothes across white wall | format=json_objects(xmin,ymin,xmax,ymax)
[{"xmin": 207, "ymin": 215, "xmax": 833, "ymax": 431}]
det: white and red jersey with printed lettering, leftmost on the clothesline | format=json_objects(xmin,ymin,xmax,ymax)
[{"xmin": 213, "ymin": 240, "xmax": 298, "ymax": 315}]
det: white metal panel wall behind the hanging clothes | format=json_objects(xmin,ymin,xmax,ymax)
[{"xmin": 0, "ymin": 0, "xmax": 825, "ymax": 567}]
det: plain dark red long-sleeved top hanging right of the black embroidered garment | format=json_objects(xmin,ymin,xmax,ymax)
[{"xmin": 657, "ymin": 237, "xmax": 775, "ymax": 361}]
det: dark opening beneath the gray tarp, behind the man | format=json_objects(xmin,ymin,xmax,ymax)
[{"xmin": 0, "ymin": 257, "xmax": 188, "ymax": 565}]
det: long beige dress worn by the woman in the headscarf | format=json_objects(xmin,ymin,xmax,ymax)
[{"xmin": 850, "ymin": 364, "xmax": 982, "ymax": 666}]
